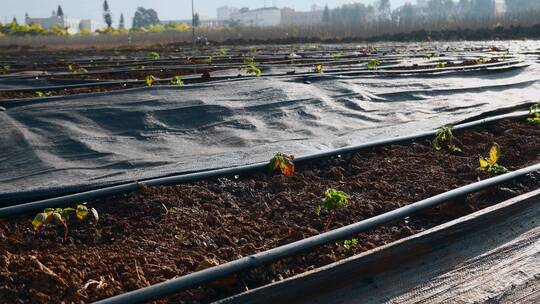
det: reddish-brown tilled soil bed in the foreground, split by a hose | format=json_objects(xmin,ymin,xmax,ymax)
[{"xmin": 0, "ymin": 120, "xmax": 540, "ymax": 303}]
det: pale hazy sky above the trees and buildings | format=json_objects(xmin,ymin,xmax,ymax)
[{"xmin": 0, "ymin": 0, "xmax": 416, "ymax": 24}]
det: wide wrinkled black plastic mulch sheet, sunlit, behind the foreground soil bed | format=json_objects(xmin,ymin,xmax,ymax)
[{"xmin": 0, "ymin": 62, "xmax": 540, "ymax": 205}]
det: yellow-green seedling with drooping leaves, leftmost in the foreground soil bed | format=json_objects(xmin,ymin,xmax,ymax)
[{"xmin": 32, "ymin": 203, "xmax": 99, "ymax": 238}]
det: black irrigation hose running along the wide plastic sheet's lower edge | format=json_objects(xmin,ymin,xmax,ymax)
[{"xmin": 0, "ymin": 111, "xmax": 529, "ymax": 218}]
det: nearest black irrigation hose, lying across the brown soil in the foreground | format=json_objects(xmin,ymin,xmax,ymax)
[{"xmin": 96, "ymin": 163, "xmax": 540, "ymax": 304}]
